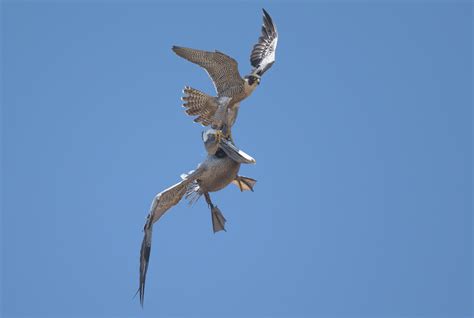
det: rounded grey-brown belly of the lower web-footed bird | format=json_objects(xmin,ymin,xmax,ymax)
[{"xmin": 198, "ymin": 158, "xmax": 240, "ymax": 192}]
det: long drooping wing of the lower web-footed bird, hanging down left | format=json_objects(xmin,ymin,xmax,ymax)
[{"xmin": 137, "ymin": 168, "xmax": 204, "ymax": 306}]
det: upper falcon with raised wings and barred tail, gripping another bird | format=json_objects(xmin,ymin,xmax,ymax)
[{"xmin": 172, "ymin": 9, "xmax": 278, "ymax": 137}]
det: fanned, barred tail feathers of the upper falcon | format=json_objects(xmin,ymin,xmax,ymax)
[{"xmin": 181, "ymin": 86, "xmax": 217, "ymax": 126}]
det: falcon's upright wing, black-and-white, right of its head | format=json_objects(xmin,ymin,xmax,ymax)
[{"xmin": 250, "ymin": 9, "xmax": 278, "ymax": 76}]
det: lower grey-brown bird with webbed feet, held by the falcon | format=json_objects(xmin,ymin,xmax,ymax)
[{"xmin": 137, "ymin": 129, "xmax": 257, "ymax": 306}]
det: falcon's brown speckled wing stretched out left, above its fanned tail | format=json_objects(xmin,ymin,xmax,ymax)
[{"xmin": 173, "ymin": 46, "xmax": 244, "ymax": 95}]
